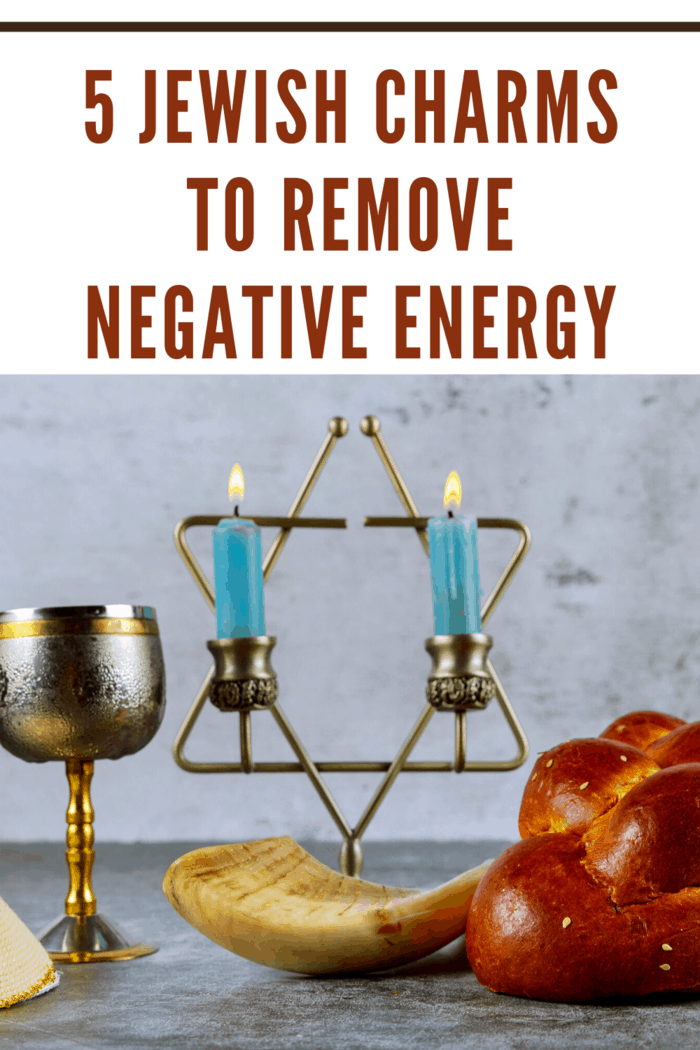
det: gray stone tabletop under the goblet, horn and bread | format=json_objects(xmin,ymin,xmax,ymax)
[{"xmin": 0, "ymin": 842, "xmax": 700, "ymax": 1050}]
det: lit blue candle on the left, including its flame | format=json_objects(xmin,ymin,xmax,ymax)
[{"xmin": 213, "ymin": 464, "xmax": 264, "ymax": 638}]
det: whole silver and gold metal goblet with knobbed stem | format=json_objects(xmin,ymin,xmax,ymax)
[{"xmin": 0, "ymin": 605, "xmax": 165, "ymax": 963}]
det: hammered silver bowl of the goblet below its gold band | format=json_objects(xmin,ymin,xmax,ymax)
[{"xmin": 0, "ymin": 634, "xmax": 165, "ymax": 762}]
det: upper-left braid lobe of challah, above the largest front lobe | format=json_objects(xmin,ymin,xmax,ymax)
[{"xmin": 518, "ymin": 737, "xmax": 659, "ymax": 839}]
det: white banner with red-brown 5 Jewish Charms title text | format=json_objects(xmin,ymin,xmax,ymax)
[{"xmin": 0, "ymin": 15, "xmax": 700, "ymax": 375}]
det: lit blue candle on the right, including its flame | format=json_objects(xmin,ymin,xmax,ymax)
[{"xmin": 428, "ymin": 473, "xmax": 482, "ymax": 634}]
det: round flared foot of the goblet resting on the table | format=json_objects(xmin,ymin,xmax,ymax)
[{"xmin": 39, "ymin": 915, "xmax": 158, "ymax": 963}]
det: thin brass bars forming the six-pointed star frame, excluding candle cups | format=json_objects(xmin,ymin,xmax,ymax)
[{"xmin": 173, "ymin": 416, "xmax": 530, "ymax": 876}]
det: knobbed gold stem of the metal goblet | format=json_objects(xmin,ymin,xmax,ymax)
[{"xmin": 66, "ymin": 758, "xmax": 98, "ymax": 916}]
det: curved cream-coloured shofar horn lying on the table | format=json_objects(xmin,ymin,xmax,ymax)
[{"xmin": 163, "ymin": 837, "xmax": 490, "ymax": 973}]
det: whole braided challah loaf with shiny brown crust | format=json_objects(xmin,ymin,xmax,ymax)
[{"xmin": 467, "ymin": 712, "xmax": 700, "ymax": 1002}]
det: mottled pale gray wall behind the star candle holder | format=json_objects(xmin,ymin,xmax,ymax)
[{"xmin": 0, "ymin": 376, "xmax": 700, "ymax": 841}]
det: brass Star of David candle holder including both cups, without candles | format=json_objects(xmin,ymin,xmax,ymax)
[{"xmin": 173, "ymin": 416, "xmax": 530, "ymax": 876}]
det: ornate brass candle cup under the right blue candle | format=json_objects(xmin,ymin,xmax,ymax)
[{"xmin": 425, "ymin": 633, "xmax": 495, "ymax": 711}]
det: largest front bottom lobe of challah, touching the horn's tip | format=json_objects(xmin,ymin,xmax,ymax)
[{"xmin": 467, "ymin": 832, "xmax": 700, "ymax": 1003}]
